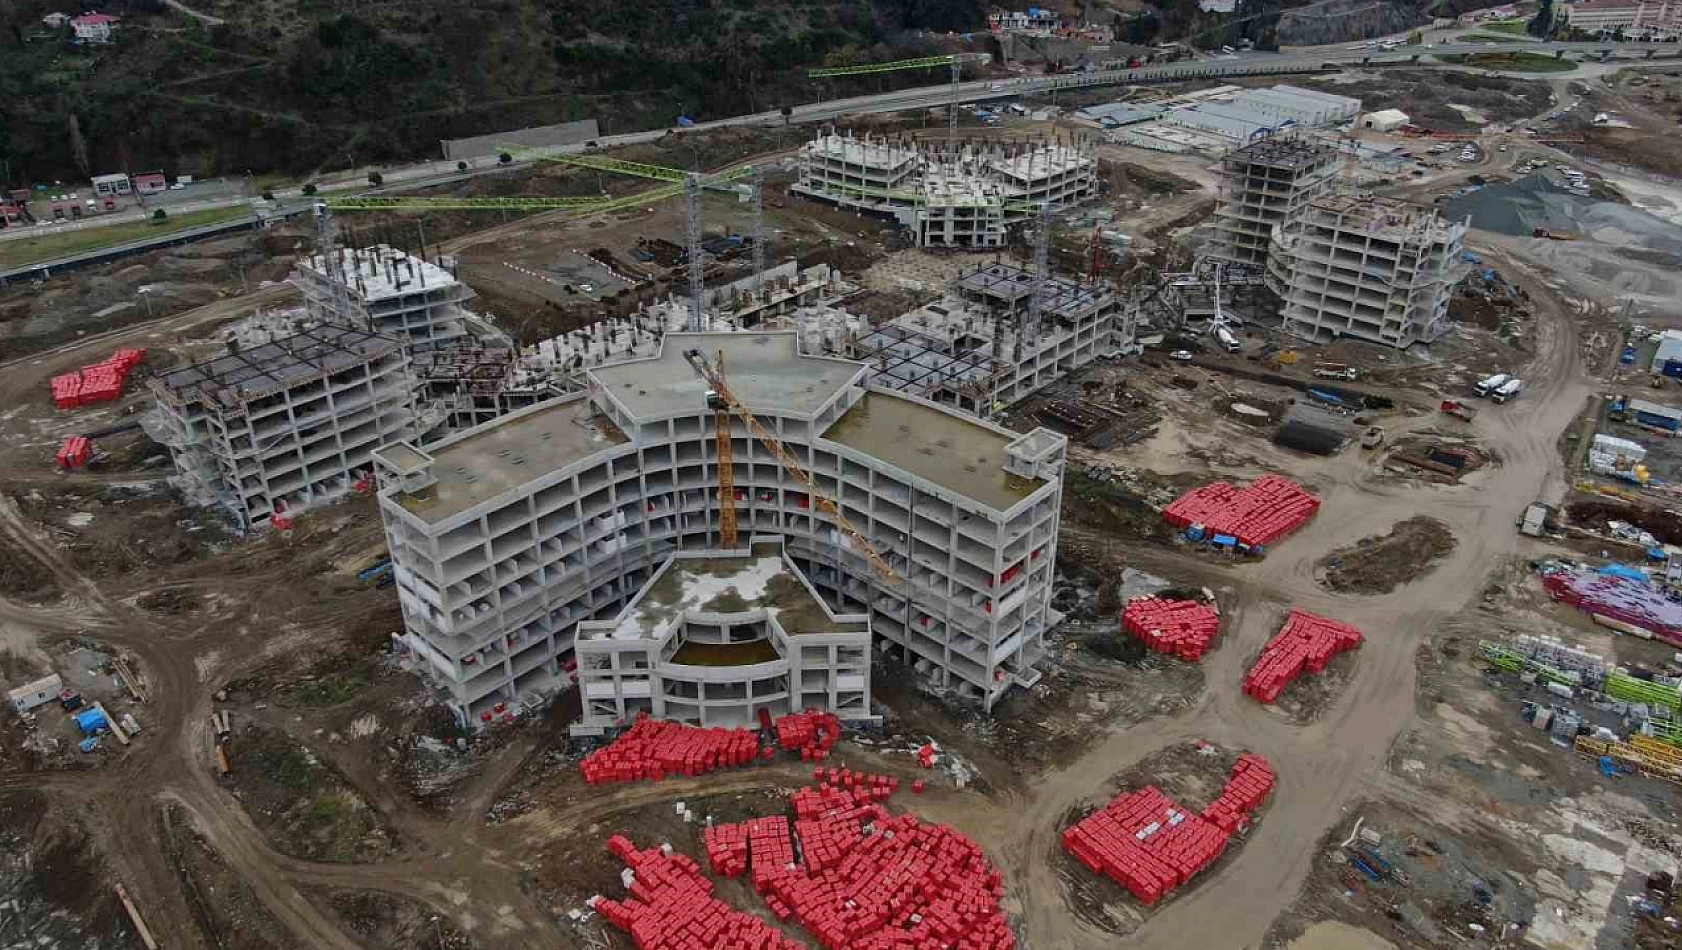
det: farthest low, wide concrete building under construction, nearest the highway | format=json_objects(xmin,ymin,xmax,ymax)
[{"xmin": 791, "ymin": 133, "xmax": 1097, "ymax": 249}]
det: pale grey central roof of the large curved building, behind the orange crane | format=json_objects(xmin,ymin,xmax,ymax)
[{"xmin": 590, "ymin": 331, "xmax": 866, "ymax": 419}]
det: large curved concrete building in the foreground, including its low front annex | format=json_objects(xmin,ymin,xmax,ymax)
[{"xmin": 375, "ymin": 331, "xmax": 1066, "ymax": 723}]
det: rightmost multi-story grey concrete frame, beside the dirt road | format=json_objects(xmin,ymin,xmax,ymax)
[{"xmin": 1267, "ymin": 195, "xmax": 1470, "ymax": 348}]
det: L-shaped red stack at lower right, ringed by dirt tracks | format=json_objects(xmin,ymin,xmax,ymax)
[{"xmin": 1063, "ymin": 755, "xmax": 1273, "ymax": 905}]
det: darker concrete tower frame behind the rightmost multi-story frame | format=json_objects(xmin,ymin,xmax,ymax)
[{"xmin": 1214, "ymin": 138, "xmax": 1337, "ymax": 267}]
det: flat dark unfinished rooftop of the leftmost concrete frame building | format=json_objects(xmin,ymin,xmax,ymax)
[{"xmin": 150, "ymin": 325, "xmax": 402, "ymax": 409}]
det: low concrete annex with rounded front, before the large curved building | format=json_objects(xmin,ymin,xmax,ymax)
[{"xmin": 572, "ymin": 543, "xmax": 871, "ymax": 735}]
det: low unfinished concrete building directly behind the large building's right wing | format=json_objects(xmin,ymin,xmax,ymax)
[{"xmin": 844, "ymin": 262, "xmax": 1137, "ymax": 417}]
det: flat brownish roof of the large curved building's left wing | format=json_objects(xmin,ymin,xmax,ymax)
[{"xmin": 395, "ymin": 395, "xmax": 627, "ymax": 523}]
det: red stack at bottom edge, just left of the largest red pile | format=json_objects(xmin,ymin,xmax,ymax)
[{"xmin": 590, "ymin": 834, "xmax": 802, "ymax": 950}]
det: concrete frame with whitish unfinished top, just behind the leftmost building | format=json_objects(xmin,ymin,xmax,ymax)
[{"xmin": 291, "ymin": 244, "xmax": 506, "ymax": 348}]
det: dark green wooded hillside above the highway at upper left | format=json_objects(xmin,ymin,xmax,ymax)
[{"xmin": 0, "ymin": 0, "xmax": 987, "ymax": 183}]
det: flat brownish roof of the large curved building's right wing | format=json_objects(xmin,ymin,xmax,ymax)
[{"xmin": 824, "ymin": 392, "xmax": 1046, "ymax": 511}]
